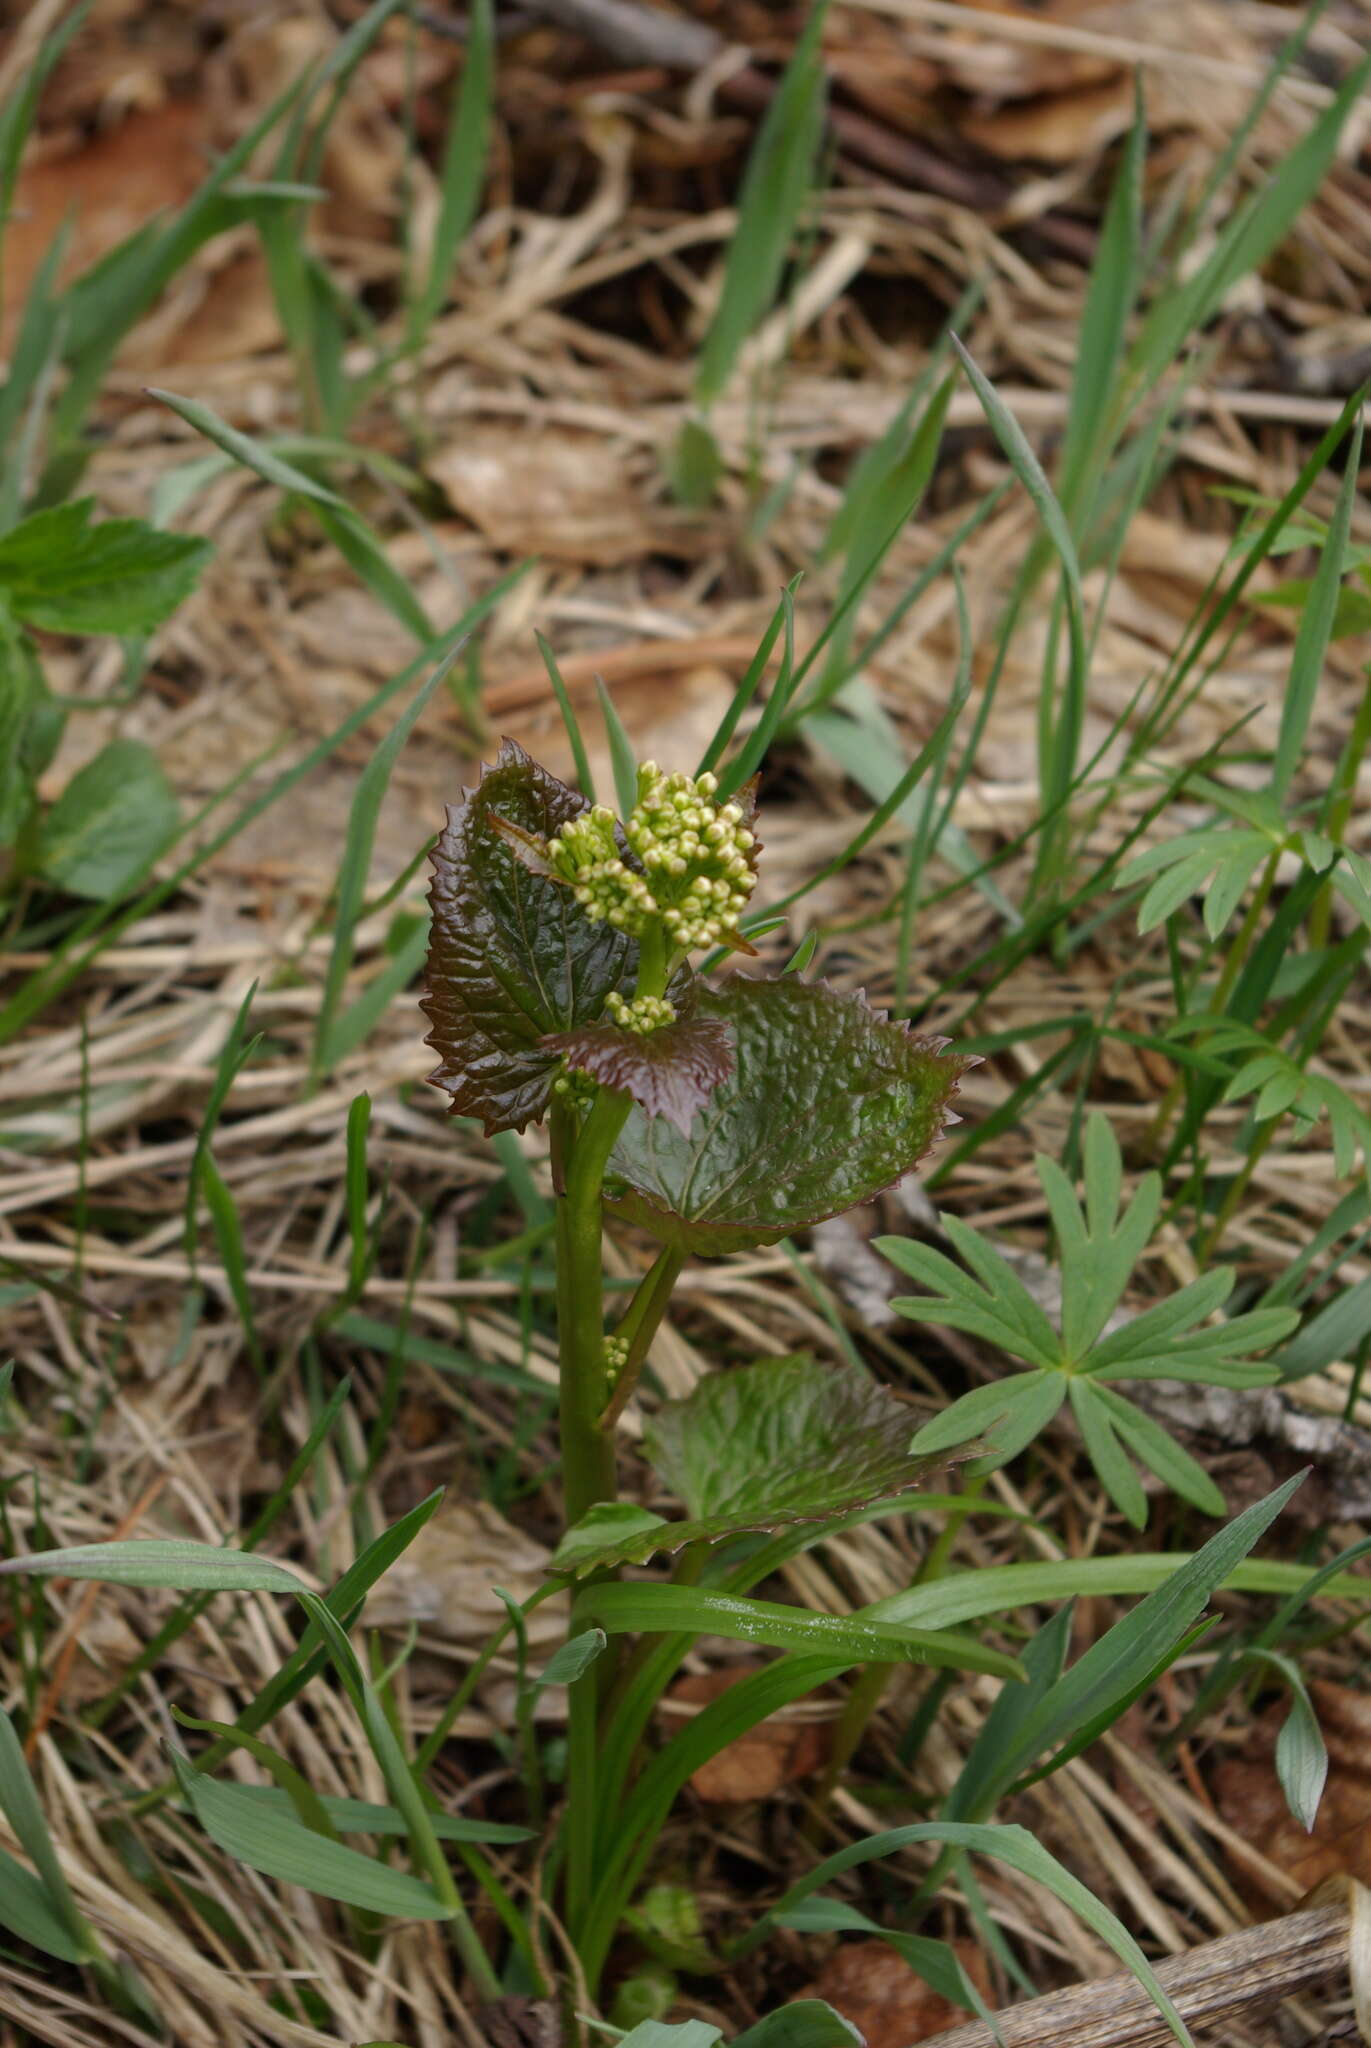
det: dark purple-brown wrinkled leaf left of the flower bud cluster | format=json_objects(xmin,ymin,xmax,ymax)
[{"xmin": 424, "ymin": 739, "xmax": 637, "ymax": 1135}]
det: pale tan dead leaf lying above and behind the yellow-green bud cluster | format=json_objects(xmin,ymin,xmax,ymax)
[{"xmin": 428, "ymin": 420, "xmax": 707, "ymax": 567}]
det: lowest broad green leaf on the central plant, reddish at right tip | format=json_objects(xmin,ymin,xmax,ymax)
[{"xmin": 553, "ymin": 1354, "xmax": 959, "ymax": 1573}]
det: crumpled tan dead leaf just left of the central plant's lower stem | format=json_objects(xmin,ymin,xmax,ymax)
[{"xmin": 363, "ymin": 1501, "xmax": 566, "ymax": 1647}]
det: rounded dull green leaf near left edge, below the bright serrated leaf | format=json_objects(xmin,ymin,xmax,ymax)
[{"xmin": 31, "ymin": 739, "xmax": 180, "ymax": 903}]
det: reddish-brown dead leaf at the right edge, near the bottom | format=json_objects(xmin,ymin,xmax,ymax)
[{"xmin": 1211, "ymin": 1679, "xmax": 1371, "ymax": 1907}]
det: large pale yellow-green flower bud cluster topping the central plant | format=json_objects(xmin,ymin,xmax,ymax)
[{"xmin": 547, "ymin": 762, "xmax": 756, "ymax": 952}]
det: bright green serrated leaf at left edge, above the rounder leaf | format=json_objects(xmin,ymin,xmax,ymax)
[{"xmin": 0, "ymin": 498, "xmax": 209, "ymax": 633}]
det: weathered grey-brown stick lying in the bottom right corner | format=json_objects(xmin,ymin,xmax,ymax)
[{"xmin": 918, "ymin": 1905, "xmax": 1348, "ymax": 2048}]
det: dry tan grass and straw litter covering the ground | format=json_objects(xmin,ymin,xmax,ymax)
[{"xmin": 0, "ymin": 0, "xmax": 1371, "ymax": 2048}]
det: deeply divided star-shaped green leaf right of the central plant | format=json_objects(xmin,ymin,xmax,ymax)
[{"xmin": 879, "ymin": 1114, "xmax": 1299, "ymax": 1528}]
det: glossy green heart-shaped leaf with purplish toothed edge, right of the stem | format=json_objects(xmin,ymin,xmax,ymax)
[{"xmin": 607, "ymin": 975, "xmax": 973, "ymax": 1257}]
